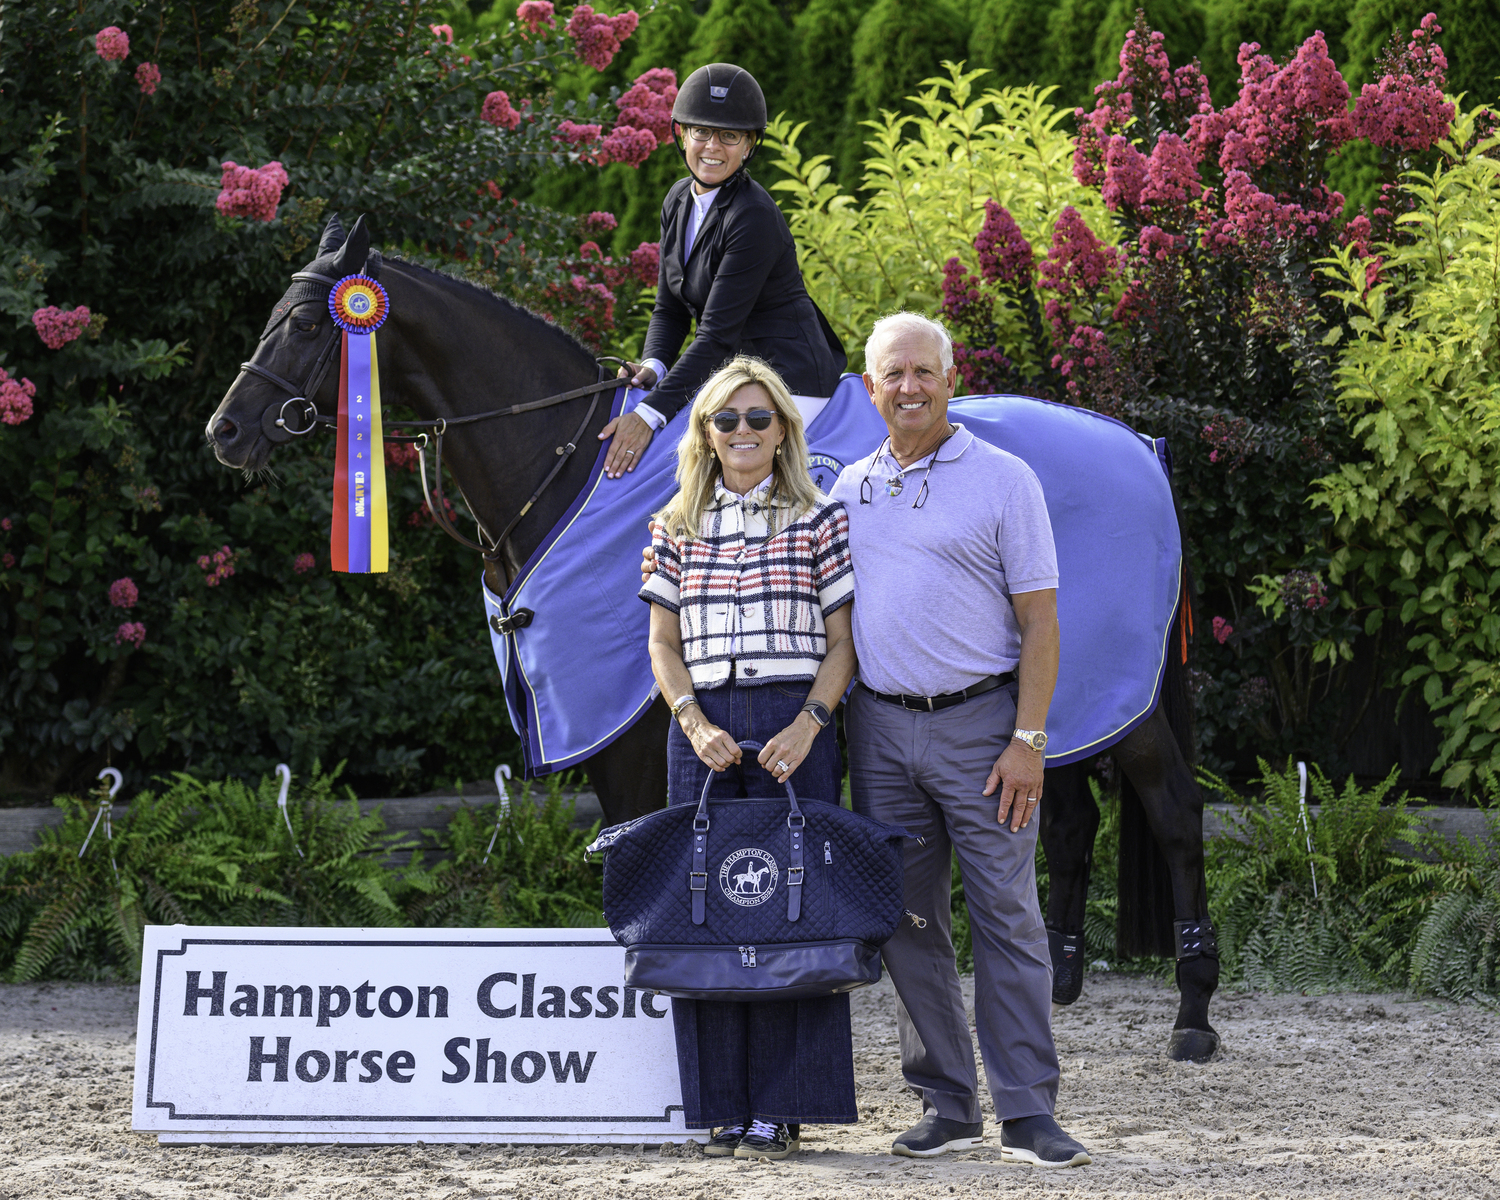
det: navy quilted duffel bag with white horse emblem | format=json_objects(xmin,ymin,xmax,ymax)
[{"xmin": 588, "ymin": 741, "xmax": 906, "ymax": 1001}]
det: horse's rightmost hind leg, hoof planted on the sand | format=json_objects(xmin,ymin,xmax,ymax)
[{"xmin": 1112, "ymin": 708, "xmax": 1220, "ymax": 1062}]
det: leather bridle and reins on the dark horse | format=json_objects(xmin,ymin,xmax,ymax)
[{"xmin": 240, "ymin": 272, "xmax": 624, "ymax": 576}]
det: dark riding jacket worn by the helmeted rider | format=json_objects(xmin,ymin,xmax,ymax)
[{"xmin": 642, "ymin": 171, "xmax": 848, "ymax": 420}]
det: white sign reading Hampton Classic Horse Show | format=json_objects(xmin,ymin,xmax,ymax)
[{"xmin": 134, "ymin": 926, "xmax": 707, "ymax": 1143}]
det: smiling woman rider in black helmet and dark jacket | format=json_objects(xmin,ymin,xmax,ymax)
[{"xmin": 599, "ymin": 63, "xmax": 848, "ymax": 479}]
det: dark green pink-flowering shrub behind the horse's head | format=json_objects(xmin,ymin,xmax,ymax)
[{"xmin": 0, "ymin": 0, "xmax": 663, "ymax": 795}]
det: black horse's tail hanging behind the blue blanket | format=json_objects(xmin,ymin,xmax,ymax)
[{"xmin": 1115, "ymin": 483, "xmax": 1194, "ymax": 957}]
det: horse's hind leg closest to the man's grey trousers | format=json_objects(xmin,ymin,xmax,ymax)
[{"xmin": 1038, "ymin": 762, "xmax": 1100, "ymax": 1004}]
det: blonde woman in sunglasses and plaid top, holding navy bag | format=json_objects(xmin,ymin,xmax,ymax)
[{"xmin": 641, "ymin": 356, "xmax": 858, "ymax": 1158}]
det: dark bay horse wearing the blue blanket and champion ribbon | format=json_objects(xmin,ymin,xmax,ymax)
[{"xmin": 207, "ymin": 218, "xmax": 1220, "ymax": 1062}]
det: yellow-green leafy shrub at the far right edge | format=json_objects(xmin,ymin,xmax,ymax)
[{"xmin": 1314, "ymin": 114, "xmax": 1500, "ymax": 786}]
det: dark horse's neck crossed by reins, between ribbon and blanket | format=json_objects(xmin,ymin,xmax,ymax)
[{"xmin": 381, "ymin": 260, "xmax": 612, "ymax": 593}]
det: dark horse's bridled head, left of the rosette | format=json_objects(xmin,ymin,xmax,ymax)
[{"xmin": 206, "ymin": 215, "xmax": 380, "ymax": 471}]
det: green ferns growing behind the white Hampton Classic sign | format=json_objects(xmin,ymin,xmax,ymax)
[{"xmin": 0, "ymin": 768, "xmax": 602, "ymax": 983}]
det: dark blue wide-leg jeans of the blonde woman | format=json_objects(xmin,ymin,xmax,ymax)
[{"xmin": 666, "ymin": 683, "xmax": 860, "ymax": 1128}]
